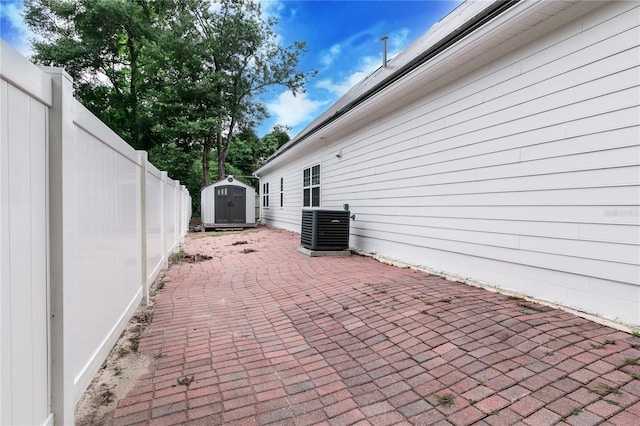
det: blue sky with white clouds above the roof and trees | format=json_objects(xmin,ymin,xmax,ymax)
[{"xmin": 0, "ymin": 0, "xmax": 461, "ymax": 136}]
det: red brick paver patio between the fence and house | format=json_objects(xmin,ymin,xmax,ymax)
[{"xmin": 114, "ymin": 228, "xmax": 640, "ymax": 426}]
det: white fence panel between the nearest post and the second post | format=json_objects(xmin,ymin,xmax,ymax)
[{"xmin": 67, "ymin": 100, "xmax": 142, "ymax": 399}]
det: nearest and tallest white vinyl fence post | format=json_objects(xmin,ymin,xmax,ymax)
[{"xmin": 43, "ymin": 68, "xmax": 75, "ymax": 425}]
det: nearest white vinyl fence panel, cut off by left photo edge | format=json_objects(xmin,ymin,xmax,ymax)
[{"xmin": 0, "ymin": 42, "xmax": 53, "ymax": 425}]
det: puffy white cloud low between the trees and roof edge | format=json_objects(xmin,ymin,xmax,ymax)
[{"xmin": 267, "ymin": 91, "xmax": 325, "ymax": 128}]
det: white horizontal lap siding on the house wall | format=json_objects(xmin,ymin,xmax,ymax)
[{"xmin": 258, "ymin": 2, "xmax": 640, "ymax": 325}]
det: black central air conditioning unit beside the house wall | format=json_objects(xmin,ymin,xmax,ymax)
[{"xmin": 300, "ymin": 210, "xmax": 350, "ymax": 251}]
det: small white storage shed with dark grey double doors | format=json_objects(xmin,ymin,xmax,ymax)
[{"xmin": 200, "ymin": 176, "xmax": 256, "ymax": 231}]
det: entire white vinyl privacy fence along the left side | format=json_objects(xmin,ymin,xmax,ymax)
[{"xmin": 0, "ymin": 41, "xmax": 191, "ymax": 425}]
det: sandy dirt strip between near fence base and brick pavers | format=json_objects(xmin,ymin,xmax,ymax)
[{"xmin": 75, "ymin": 274, "xmax": 165, "ymax": 426}]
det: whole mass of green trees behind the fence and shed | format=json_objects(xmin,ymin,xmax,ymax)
[{"xmin": 25, "ymin": 0, "xmax": 314, "ymax": 194}]
